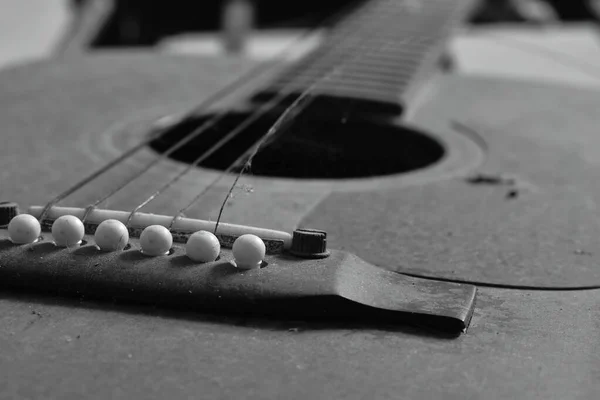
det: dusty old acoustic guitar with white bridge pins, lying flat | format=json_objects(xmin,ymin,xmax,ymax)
[{"xmin": 0, "ymin": 0, "xmax": 600, "ymax": 399}]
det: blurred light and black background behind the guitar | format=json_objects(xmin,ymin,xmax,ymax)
[{"xmin": 0, "ymin": 0, "xmax": 600, "ymax": 85}]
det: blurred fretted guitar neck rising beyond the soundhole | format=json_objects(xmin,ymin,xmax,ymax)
[{"xmin": 255, "ymin": 0, "xmax": 474, "ymax": 114}]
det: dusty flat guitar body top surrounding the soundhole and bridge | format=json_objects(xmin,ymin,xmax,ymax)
[{"xmin": 0, "ymin": 53, "xmax": 600, "ymax": 399}]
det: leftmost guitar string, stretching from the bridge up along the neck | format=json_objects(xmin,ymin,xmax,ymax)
[{"xmin": 38, "ymin": 0, "xmax": 360, "ymax": 222}]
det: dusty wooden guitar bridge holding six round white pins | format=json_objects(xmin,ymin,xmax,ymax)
[{"xmin": 0, "ymin": 207, "xmax": 476, "ymax": 335}]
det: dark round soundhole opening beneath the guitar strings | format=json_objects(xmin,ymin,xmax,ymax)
[{"xmin": 150, "ymin": 112, "xmax": 444, "ymax": 179}]
